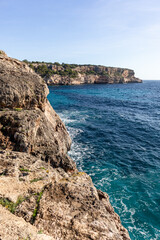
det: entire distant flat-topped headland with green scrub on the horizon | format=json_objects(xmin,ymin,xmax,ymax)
[{"xmin": 28, "ymin": 62, "xmax": 142, "ymax": 85}]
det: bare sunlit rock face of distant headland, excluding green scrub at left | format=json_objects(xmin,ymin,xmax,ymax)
[{"xmin": 41, "ymin": 65, "xmax": 142, "ymax": 85}]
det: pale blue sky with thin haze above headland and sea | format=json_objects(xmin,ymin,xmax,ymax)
[{"xmin": 0, "ymin": 0, "xmax": 160, "ymax": 80}]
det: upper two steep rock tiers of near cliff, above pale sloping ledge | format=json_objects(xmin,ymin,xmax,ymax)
[{"xmin": 0, "ymin": 51, "xmax": 75, "ymax": 169}]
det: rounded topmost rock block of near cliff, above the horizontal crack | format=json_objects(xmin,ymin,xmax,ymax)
[{"xmin": 0, "ymin": 51, "xmax": 49, "ymax": 110}]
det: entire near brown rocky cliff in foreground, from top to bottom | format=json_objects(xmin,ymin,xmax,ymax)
[{"xmin": 0, "ymin": 51, "xmax": 130, "ymax": 240}]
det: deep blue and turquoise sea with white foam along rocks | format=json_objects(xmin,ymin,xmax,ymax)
[{"xmin": 48, "ymin": 81, "xmax": 160, "ymax": 240}]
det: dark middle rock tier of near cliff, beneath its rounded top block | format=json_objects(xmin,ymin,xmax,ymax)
[{"xmin": 0, "ymin": 102, "xmax": 75, "ymax": 170}]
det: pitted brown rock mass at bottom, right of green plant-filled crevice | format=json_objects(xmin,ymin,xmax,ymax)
[{"xmin": 35, "ymin": 172, "xmax": 129, "ymax": 240}]
